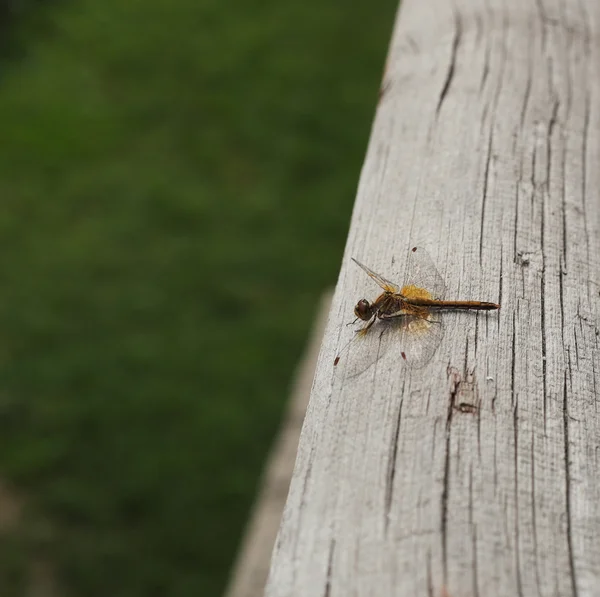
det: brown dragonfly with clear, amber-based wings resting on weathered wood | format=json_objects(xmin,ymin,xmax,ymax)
[{"xmin": 334, "ymin": 247, "xmax": 500, "ymax": 369}]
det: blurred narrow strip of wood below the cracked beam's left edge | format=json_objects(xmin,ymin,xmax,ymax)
[{"xmin": 225, "ymin": 292, "xmax": 331, "ymax": 597}]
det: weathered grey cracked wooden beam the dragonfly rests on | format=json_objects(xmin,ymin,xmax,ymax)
[{"xmin": 266, "ymin": 0, "xmax": 600, "ymax": 597}]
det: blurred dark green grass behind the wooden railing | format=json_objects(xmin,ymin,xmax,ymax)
[{"xmin": 0, "ymin": 0, "xmax": 397, "ymax": 597}]
